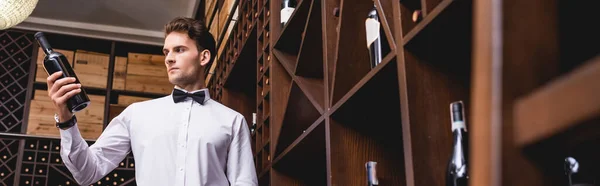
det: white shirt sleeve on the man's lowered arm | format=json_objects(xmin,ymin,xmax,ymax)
[{"xmin": 227, "ymin": 115, "xmax": 258, "ymax": 186}]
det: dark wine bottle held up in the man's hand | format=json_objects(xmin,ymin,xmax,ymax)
[{"xmin": 34, "ymin": 32, "xmax": 90, "ymax": 113}]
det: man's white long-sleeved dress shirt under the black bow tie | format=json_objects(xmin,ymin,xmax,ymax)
[{"xmin": 60, "ymin": 89, "xmax": 258, "ymax": 186}]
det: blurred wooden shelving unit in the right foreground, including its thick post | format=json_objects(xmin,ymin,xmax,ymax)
[{"xmin": 470, "ymin": 0, "xmax": 600, "ymax": 186}]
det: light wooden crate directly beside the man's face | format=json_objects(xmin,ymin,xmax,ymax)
[{"xmin": 125, "ymin": 53, "xmax": 173, "ymax": 94}]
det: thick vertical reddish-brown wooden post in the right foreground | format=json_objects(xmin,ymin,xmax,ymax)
[{"xmin": 467, "ymin": 0, "xmax": 502, "ymax": 186}]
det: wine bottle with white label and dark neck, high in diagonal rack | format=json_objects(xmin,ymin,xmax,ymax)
[{"xmin": 365, "ymin": 5, "xmax": 382, "ymax": 68}]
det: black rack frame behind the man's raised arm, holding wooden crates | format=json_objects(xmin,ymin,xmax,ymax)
[{"xmin": 0, "ymin": 29, "xmax": 157, "ymax": 185}]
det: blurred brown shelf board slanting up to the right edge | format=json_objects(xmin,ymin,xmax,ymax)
[{"xmin": 514, "ymin": 54, "xmax": 600, "ymax": 146}]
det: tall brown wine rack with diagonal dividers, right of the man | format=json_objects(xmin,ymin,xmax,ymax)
[{"xmin": 211, "ymin": 0, "xmax": 472, "ymax": 186}]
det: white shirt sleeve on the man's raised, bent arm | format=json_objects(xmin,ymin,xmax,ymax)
[{"xmin": 60, "ymin": 104, "xmax": 131, "ymax": 185}]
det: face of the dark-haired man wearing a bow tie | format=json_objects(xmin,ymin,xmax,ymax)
[{"xmin": 163, "ymin": 32, "xmax": 210, "ymax": 86}]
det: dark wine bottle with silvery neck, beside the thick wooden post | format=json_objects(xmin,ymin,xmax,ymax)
[{"xmin": 446, "ymin": 101, "xmax": 469, "ymax": 186}]
